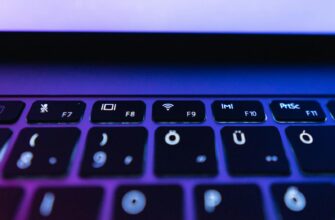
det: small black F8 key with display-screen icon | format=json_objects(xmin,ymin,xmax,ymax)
[{"xmin": 91, "ymin": 101, "xmax": 145, "ymax": 122}]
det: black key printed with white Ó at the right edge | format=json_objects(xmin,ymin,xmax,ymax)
[{"xmin": 286, "ymin": 126, "xmax": 335, "ymax": 173}]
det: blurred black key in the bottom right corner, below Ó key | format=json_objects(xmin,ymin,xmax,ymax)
[{"xmin": 272, "ymin": 183, "xmax": 335, "ymax": 220}]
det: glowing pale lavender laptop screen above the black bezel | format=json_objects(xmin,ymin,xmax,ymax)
[{"xmin": 0, "ymin": 0, "xmax": 335, "ymax": 34}]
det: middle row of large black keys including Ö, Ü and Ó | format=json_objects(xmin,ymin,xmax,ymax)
[{"xmin": 0, "ymin": 126, "xmax": 335, "ymax": 178}]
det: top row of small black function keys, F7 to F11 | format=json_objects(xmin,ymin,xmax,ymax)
[{"xmin": 0, "ymin": 100, "xmax": 335, "ymax": 124}]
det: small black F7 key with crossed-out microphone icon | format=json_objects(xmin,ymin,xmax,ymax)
[{"xmin": 27, "ymin": 101, "xmax": 85, "ymax": 123}]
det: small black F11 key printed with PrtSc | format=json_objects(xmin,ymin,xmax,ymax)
[{"xmin": 270, "ymin": 100, "xmax": 326, "ymax": 122}]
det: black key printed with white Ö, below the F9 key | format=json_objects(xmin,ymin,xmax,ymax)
[{"xmin": 155, "ymin": 127, "xmax": 217, "ymax": 176}]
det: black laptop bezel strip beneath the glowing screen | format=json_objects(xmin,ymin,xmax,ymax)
[{"xmin": 0, "ymin": 32, "xmax": 335, "ymax": 64}]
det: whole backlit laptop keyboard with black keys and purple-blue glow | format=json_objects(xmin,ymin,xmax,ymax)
[{"xmin": 0, "ymin": 97, "xmax": 335, "ymax": 220}]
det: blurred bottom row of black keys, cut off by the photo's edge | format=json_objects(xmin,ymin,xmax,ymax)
[{"xmin": 0, "ymin": 183, "xmax": 335, "ymax": 220}]
